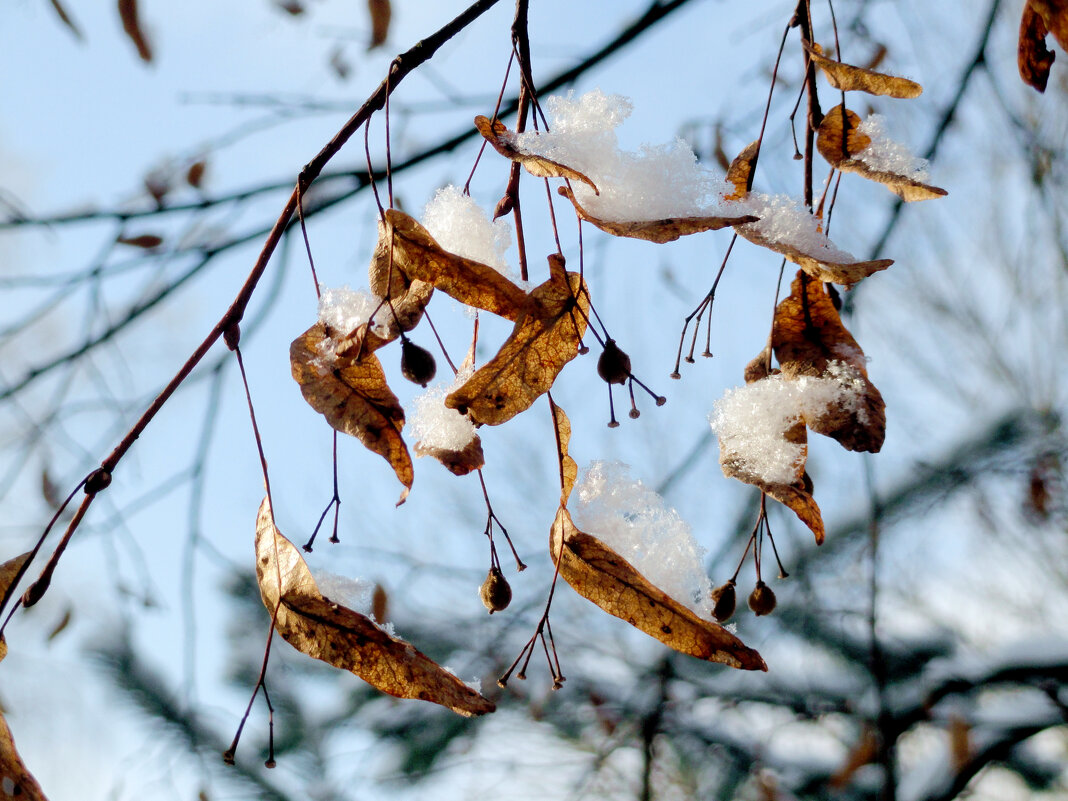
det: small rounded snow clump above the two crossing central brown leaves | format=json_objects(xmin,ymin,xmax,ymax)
[{"xmin": 423, "ymin": 184, "xmax": 512, "ymax": 276}]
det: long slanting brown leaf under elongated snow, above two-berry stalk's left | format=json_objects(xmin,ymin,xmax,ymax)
[{"xmin": 549, "ymin": 506, "xmax": 768, "ymax": 671}]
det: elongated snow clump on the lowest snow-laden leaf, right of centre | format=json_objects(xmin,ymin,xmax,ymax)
[{"xmin": 575, "ymin": 461, "xmax": 712, "ymax": 619}]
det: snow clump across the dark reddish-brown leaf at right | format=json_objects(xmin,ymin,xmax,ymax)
[{"xmin": 709, "ymin": 361, "xmax": 866, "ymax": 484}]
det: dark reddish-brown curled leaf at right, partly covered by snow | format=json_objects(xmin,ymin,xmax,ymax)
[{"xmin": 771, "ymin": 272, "xmax": 886, "ymax": 453}]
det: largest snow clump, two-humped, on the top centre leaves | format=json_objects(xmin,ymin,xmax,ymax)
[{"xmin": 516, "ymin": 90, "xmax": 726, "ymax": 222}]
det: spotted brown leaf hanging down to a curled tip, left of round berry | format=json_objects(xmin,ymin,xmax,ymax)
[{"xmin": 289, "ymin": 323, "xmax": 414, "ymax": 504}]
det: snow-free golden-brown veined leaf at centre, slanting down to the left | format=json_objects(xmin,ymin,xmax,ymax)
[{"xmin": 445, "ymin": 253, "xmax": 590, "ymax": 433}]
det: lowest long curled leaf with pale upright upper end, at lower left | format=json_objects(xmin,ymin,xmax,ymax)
[{"xmin": 256, "ymin": 499, "xmax": 494, "ymax": 717}]
